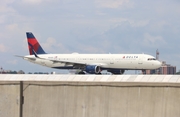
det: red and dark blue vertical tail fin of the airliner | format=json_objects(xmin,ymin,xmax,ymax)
[{"xmin": 26, "ymin": 32, "xmax": 46, "ymax": 55}]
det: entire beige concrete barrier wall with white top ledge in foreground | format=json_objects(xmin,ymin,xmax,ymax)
[{"xmin": 0, "ymin": 75, "xmax": 180, "ymax": 117}]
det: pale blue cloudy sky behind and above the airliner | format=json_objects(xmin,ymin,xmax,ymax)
[{"xmin": 0, "ymin": 0, "xmax": 180, "ymax": 73}]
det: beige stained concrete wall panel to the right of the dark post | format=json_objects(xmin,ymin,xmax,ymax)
[{"xmin": 23, "ymin": 82, "xmax": 180, "ymax": 117}]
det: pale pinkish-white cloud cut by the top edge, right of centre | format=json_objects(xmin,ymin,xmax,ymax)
[{"xmin": 95, "ymin": 0, "xmax": 129, "ymax": 8}]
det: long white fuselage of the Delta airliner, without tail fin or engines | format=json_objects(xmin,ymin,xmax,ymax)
[{"xmin": 24, "ymin": 54, "xmax": 161, "ymax": 70}]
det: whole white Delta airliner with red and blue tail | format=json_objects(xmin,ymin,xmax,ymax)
[{"xmin": 19, "ymin": 32, "xmax": 161, "ymax": 74}]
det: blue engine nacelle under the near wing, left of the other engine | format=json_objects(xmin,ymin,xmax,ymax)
[{"xmin": 85, "ymin": 65, "xmax": 101, "ymax": 74}]
